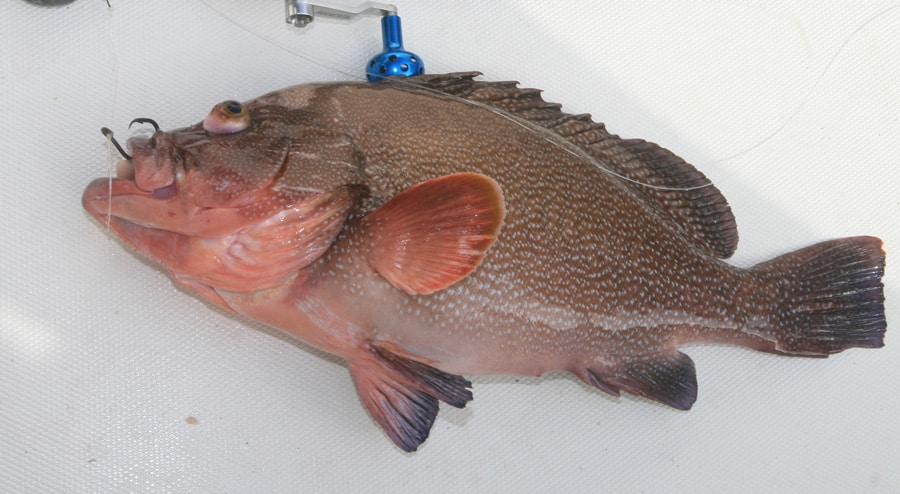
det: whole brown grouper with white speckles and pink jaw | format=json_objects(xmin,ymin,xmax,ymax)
[{"xmin": 82, "ymin": 72, "xmax": 886, "ymax": 452}]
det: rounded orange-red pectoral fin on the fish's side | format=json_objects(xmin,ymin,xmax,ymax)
[{"xmin": 363, "ymin": 173, "xmax": 506, "ymax": 294}]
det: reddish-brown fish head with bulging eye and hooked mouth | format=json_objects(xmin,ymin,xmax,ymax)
[{"xmin": 82, "ymin": 92, "xmax": 363, "ymax": 291}]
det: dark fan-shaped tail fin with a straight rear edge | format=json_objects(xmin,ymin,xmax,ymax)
[{"xmin": 753, "ymin": 237, "xmax": 886, "ymax": 356}]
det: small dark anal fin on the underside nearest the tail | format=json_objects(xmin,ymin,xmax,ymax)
[{"xmin": 587, "ymin": 351, "xmax": 697, "ymax": 410}]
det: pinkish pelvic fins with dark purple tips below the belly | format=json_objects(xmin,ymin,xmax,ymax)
[{"xmin": 350, "ymin": 343, "xmax": 472, "ymax": 452}]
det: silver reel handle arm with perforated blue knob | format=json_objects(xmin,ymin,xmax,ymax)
[{"xmin": 284, "ymin": 0, "xmax": 425, "ymax": 82}]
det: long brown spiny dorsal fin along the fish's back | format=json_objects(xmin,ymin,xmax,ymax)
[{"xmin": 390, "ymin": 72, "xmax": 738, "ymax": 258}]
